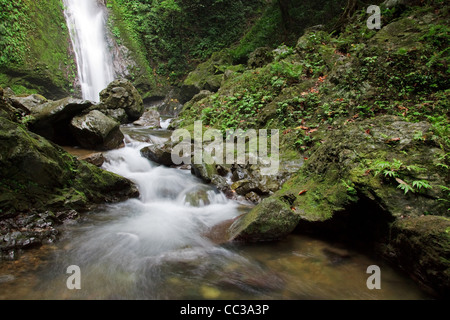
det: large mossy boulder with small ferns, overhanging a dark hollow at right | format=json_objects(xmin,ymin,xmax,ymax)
[{"xmin": 230, "ymin": 116, "xmax": 449, "ymax": 240}]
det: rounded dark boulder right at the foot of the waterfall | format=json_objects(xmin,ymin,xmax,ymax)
[{"xmin": 99, "ymin": 79, "xmax": 144, "ymax": 122}]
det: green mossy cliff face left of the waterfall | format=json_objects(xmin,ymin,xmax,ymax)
[{"xmin": 0, "ymin": 0, "xmax": 76, "ymax": 98}]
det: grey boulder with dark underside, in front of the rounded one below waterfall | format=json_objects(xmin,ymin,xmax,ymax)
[{"xmin": 71, "ymin": 110, "xmax": 125, "ymax": 150}]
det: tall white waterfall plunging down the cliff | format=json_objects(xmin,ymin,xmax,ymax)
[{"xmin": 64, "ymin": 0, "xmax": 115, "ymax": 102}]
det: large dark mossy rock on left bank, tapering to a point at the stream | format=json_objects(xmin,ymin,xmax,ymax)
[{"xmin": 0, "ymin": 118, "xmax": 137, "ymax": 216}]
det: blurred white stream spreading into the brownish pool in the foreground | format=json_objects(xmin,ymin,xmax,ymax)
[{"xmin": 0, "ymin": 126, "xmax": 428, "ymax": 300}]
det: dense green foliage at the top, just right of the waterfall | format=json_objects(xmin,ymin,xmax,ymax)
[{"xmin": 108, "ymin": 0, "xmax": 262, "ymax": 80}]
